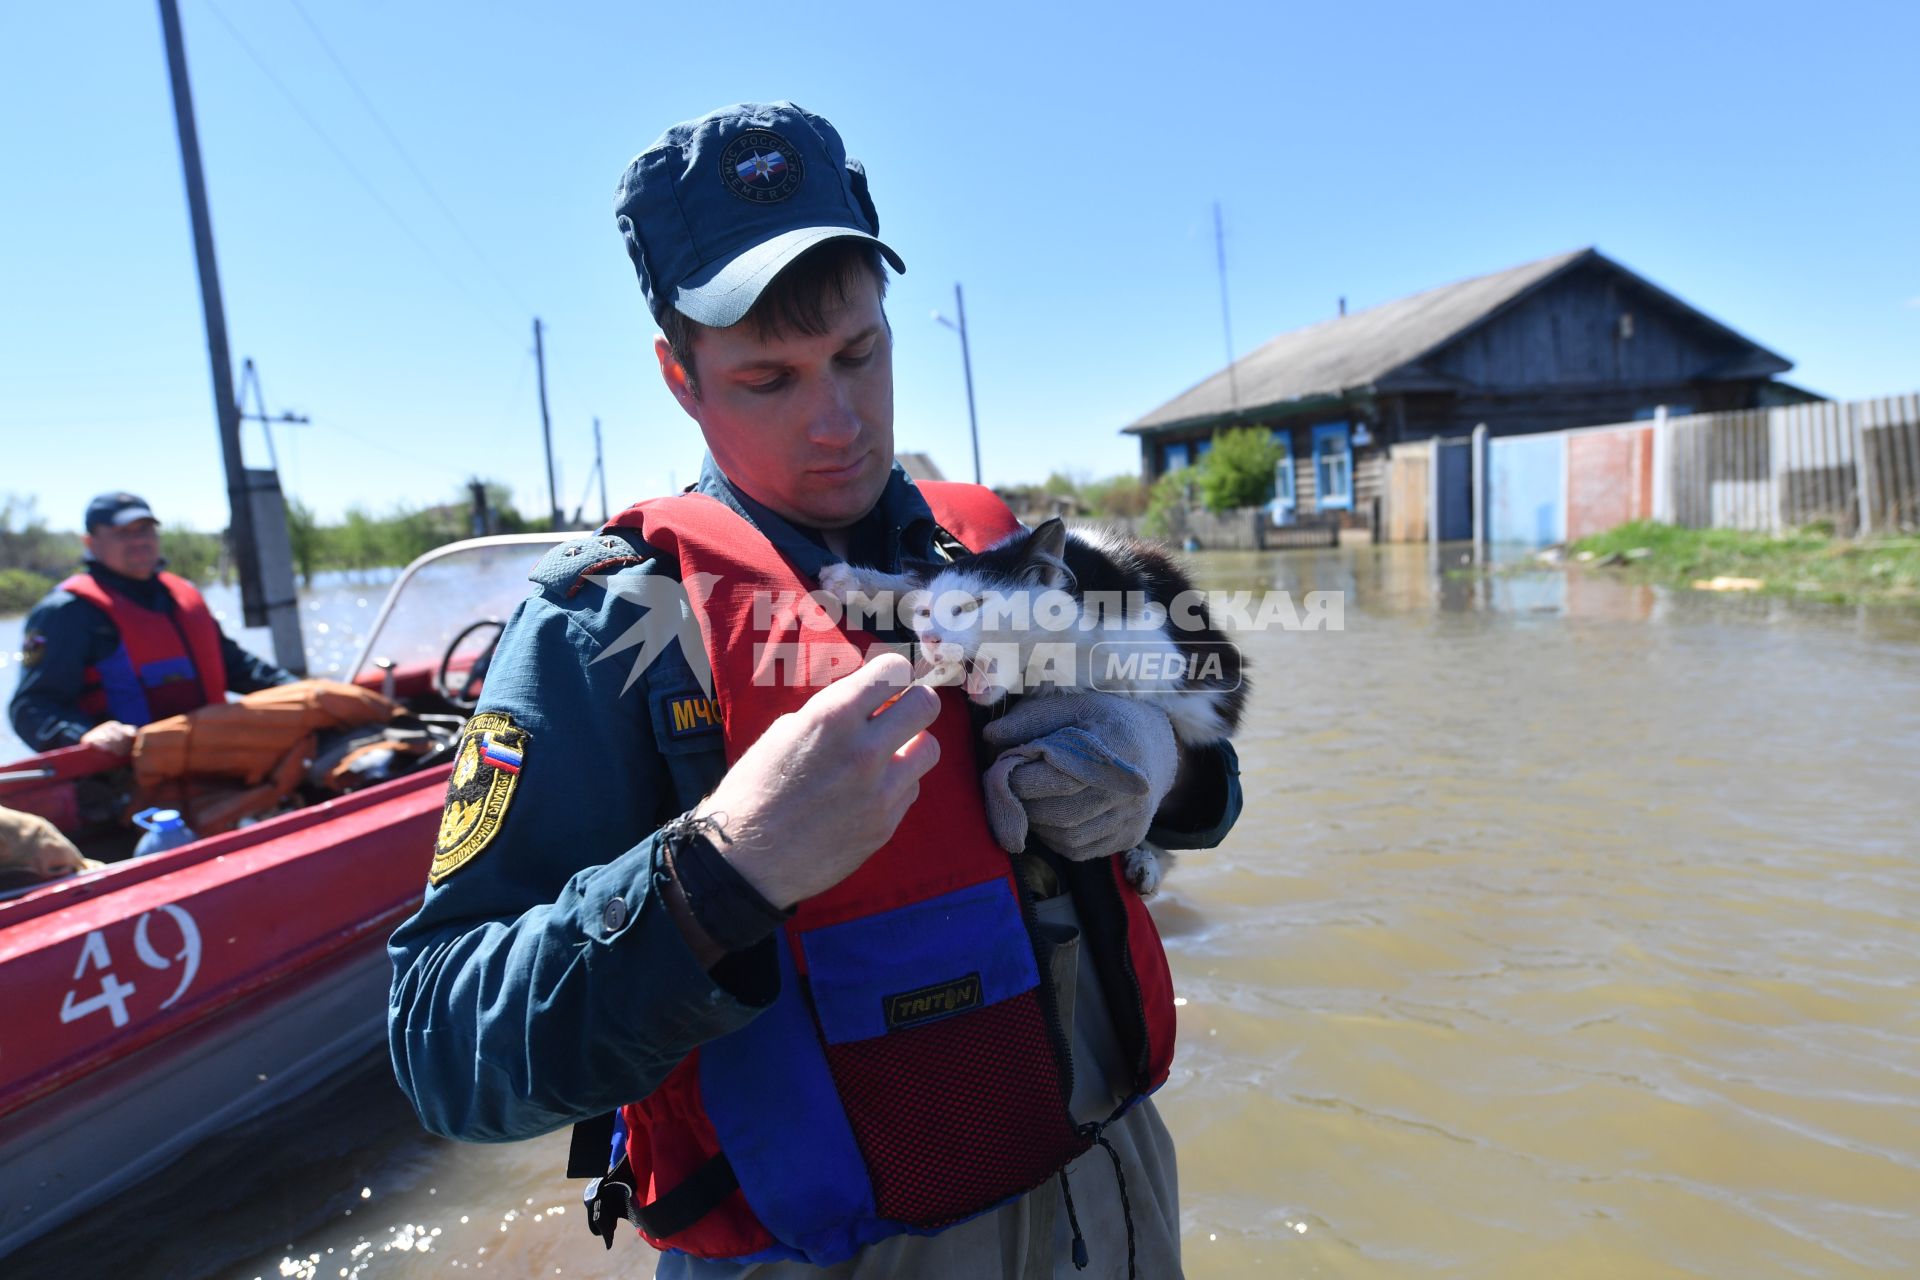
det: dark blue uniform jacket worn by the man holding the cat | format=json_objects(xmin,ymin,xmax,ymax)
[{"xmin": 388, "ymin": 459, "xmax": 1240, "ymax": 1142}]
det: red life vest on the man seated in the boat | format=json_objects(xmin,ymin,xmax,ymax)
[{"xmin": 60, "ymin": 572, "xmax": 227, "ymax": 727}]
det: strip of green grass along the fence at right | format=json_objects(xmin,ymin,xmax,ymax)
[{"xmin": 1567, "ymin": 520, "xmax": 1920, "ymax": 604}]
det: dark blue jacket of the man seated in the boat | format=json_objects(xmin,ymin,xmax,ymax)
[{"xmin": 8, "ymin": 560, "xmax": 294, "ymax": 750}]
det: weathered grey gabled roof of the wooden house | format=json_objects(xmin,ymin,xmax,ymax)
[{"xmin": 1125, "ymin": 248, "xmax": 1789, "ymax": 432}]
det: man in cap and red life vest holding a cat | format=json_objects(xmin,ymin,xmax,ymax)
[{"xmin": 390, "ymin": 104, "xmax": 1240, "ymax": 1280}]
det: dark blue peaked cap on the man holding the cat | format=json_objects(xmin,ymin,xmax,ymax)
[{"xmin": 614, "ymin": 102, "xmax": 906, "ymax": 328}]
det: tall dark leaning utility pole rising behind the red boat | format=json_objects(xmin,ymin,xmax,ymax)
[{"xmin": 159, "ymin": 0, "xmax": 307, "ymax": 674}]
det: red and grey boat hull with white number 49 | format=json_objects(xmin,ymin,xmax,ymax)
[{"xmin": 0, "ymin": 768, "xmax": 447, "ymax": 1255}]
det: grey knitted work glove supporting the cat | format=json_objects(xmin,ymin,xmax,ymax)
[{"xmin": 985, "ymin": 693, "xmax": 1181, "ymax": 862}]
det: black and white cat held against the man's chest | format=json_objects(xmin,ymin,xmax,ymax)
[{"xmin": 820, "ymin": 518, "xmax": 1246, "ymax": 894}]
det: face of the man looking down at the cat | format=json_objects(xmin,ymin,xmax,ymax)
[{"xmin": 655, "ymin": 271, "xmax": 893, "ymax": 530}]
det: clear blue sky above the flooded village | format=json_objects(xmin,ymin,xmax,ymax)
[{"xmin": 0, "ymin": 0, "xmax": 1920, "ymax": 528}]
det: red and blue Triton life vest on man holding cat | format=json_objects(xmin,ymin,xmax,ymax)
[{"xmin": 611, "ymin": 484, "xmax": 1173, "ymax": 1265}]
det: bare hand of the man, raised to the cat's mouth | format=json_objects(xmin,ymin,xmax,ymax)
[{"xmin": 693, "ymin": 654, "xmax": 941, "ymax": 908}]
